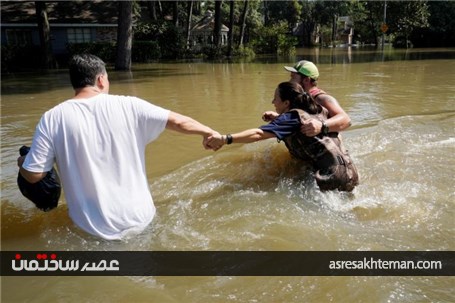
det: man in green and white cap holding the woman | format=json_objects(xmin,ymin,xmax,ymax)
[{"xmin": 284, "ymin": 60, "xmax": 351, "ymax": 137}]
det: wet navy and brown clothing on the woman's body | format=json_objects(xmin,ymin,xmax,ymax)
[{"xmin": 260, "ymin": 108, "xmax": 359, "ymax": 191}]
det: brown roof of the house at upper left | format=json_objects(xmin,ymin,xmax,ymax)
[{"xmin": 0, "ymin": 0, "xmax": 118, "ymax": 24}]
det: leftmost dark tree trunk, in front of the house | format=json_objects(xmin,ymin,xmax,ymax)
[{"xmin": 35, "ymin": 1, "xmax": 55, "ymax": 69}]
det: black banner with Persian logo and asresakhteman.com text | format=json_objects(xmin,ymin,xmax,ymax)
[{"xmin": 0, "ymin": 251, "xmax": 455, "ymax": 276}]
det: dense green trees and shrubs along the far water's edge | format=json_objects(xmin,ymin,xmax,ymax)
[{"xmin": 2, "ymin": 0, "xmax": 455, "ymax": 71}]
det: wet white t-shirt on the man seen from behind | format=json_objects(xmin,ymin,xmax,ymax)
[{"xmin": 23, "ymin": 94, "xmax": 169, "ymax": 239}]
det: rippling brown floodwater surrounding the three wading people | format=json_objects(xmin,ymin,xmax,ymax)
[{"xmin": 1, "ymin": 48, "xmax": 455, "ymax": 302}]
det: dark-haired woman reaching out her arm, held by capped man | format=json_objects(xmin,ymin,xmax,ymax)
[{"xmin": 207, "ymin": 82, "xmax": 359, "ymax": 192}]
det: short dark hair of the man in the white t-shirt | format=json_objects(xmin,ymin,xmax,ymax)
[{"xmin": 69, "ymin": 54, "xmax": 106, "ymax": 89}]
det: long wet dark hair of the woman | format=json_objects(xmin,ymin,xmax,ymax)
[{"xmin": 278, "ymin": 82, "xmax": 322, "ymax": 114}]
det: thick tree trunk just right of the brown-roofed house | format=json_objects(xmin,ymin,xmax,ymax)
[{"xmin": 115, "ymin": 1, "xmax": 133, "ymax": 70}]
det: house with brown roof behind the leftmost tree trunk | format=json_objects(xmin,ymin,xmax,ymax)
[{"xmin": 0, "ymin": 0, "xmax": 118, "ymax": 56}]
